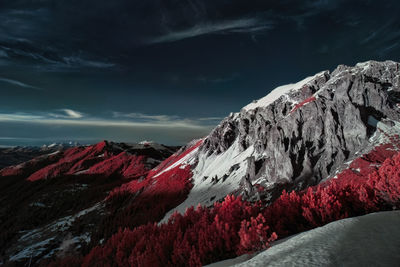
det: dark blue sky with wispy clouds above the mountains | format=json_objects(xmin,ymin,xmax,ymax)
[{"xmin": 0, "ymin": 0, "xmax": 400, "ymax": 146}]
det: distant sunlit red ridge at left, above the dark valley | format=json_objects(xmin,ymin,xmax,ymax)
[{"xmin": 0, "ymin": 141, "xmax": 174, "ymax": 181}]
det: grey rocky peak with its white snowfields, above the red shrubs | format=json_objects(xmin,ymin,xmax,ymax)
[{"xmin": 163, "ymin": 61, "xmax": 400, "ymax": 221}]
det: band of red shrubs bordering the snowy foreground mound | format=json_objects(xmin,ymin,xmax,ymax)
[{"xmin": 76, "ymin": 149, "xmax": 400, "ymax": 266}]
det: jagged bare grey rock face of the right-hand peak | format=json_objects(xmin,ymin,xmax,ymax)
[{"xmin": 200, "ymin": 61, "xmax": 400, "ymax": 191}]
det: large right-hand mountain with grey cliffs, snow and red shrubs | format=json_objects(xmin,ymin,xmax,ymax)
[{"xmin": 76, "ymin": 61, "xmax": 400, "ymax": 266}]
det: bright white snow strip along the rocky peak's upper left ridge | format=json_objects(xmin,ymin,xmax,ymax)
[{"xmin": 243, "ymin": 71, "xmax": 325, "ymax": 110}]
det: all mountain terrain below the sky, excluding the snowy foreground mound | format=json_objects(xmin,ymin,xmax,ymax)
[{"xmin": 0, "ymin": 61, "xmax": 400, "ymax": 266}]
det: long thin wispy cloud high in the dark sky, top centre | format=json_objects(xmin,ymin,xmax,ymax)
[{"xmin": 149, "ymin": 18, "xmax": 274, "ymax": 43}]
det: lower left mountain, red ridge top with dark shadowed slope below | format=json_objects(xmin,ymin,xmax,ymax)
[{"xmin": 0, "ymin": 141, "xmax": 177, "ymax": 265}]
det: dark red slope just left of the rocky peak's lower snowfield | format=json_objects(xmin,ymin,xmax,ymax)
[{"xmin": 87, "ymin": 165, "xmax": 193, "ymax": 250}]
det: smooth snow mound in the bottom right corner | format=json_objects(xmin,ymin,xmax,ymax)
[{"xmin": 208, "ymin": 211, "xmax": 400, "ymax": 267}]
